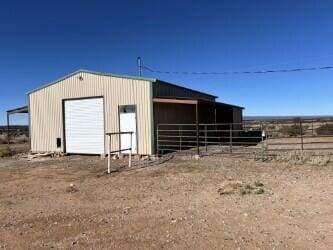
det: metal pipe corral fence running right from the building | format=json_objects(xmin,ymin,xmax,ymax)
[{"xmin": 156, "ymin": 119, "xmax": 333, "ymax": 158}]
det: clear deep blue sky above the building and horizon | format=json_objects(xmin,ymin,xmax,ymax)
[{"xmin": 0, "ymin": 0, "xmax": 333, "ymax": 124}]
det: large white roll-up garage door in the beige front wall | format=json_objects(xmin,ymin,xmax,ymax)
[{"xmin": 64, "ymin": 98, "xmax": 104, "ymax": 154}]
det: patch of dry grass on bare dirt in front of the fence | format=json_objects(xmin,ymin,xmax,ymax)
[{"xmin": 217, "ymin": 181, "xmax": 265, "ymax": 195}]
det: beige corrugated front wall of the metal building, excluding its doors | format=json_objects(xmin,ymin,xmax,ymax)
[{"xmin": 28, "ymin": 72, "xmax": 153, "ymax": 154}]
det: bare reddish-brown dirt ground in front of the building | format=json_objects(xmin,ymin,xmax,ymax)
[{"xmin": 0, "ymin": 149, "xmax": 333, "ymax": 249}]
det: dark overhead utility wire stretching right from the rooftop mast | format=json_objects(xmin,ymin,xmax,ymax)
[{"xmin": 141, "ymin": 66, "xmax": 333, "ymax": 75}]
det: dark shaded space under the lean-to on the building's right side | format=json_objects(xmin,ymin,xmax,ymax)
[{"xmin": 154, "ymin": 100, "xmax": 242, "ymax": 154}]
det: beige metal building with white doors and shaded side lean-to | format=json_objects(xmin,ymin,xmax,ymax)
[{"xmin": 22, "ymin": 70, "xmax": 243, "ymax": 155}]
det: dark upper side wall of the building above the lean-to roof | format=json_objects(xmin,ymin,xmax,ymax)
[{"xmin": 153, "ymin": 80, "xmax": 215, "ymax": 101}]
